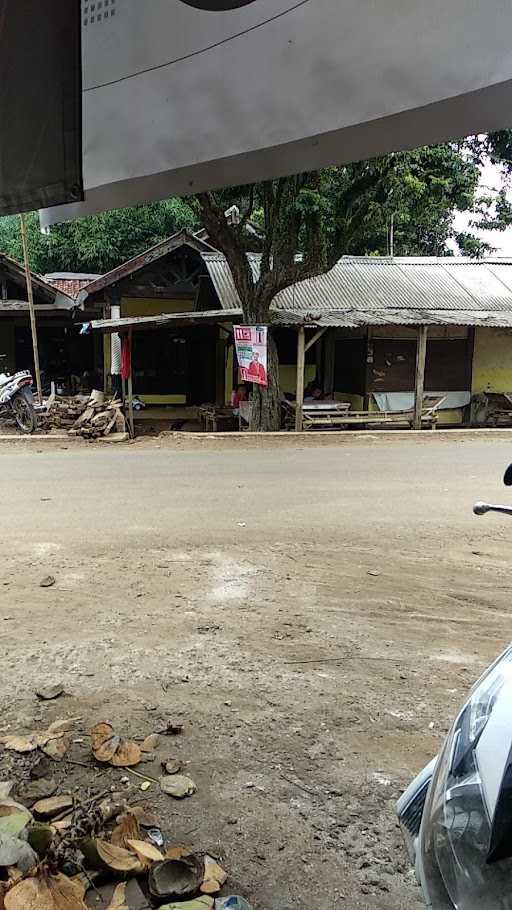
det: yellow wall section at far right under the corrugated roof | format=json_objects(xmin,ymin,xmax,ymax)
[{"xmin": 472, "ymin": 328, "xmax": 512, "ymax": 394}]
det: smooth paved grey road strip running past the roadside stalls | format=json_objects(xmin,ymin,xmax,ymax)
[{"xmin": 0, "ymin": 436, "xmax": 512, "ymax": 550}]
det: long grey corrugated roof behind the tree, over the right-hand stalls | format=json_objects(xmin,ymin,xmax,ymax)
[{"xmin": 203, "ymin": 253, "xmax": 512, "ymax": 326}]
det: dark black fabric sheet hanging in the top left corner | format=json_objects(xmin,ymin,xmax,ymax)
[{"xmin": 0, "ymin": 0, "xmax": 83, "ymax": 215}]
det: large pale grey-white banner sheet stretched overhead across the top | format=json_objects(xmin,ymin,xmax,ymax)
[{"xmin": 41, "ymin": 0, "xmax": 512, "ymax": 224}]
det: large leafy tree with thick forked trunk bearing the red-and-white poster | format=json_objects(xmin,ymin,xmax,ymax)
[{"xmin": 195, "ymin": 145, "xmax": 488, "ymax": 430}]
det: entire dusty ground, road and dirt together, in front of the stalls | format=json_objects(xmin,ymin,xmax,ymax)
[{"xmin": 0, "ymin": 434, "xmax": 512, "ymax": 910}]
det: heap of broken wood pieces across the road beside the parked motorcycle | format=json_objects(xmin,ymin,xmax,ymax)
[{"xmin": 37, "ymin": 391, "xmax": 126, "ymax": 439}]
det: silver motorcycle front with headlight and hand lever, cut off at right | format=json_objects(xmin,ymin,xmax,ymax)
[{"xmin": 396, "ymin": 465, "xmax": 512, "ymax": 910}]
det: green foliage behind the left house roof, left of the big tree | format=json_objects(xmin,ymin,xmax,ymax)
[{"xmin": 0, "ymin": 199, "xmax": 198, "ymax": 275}]
